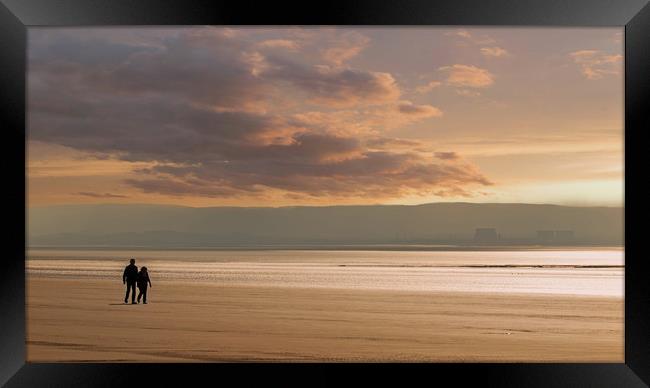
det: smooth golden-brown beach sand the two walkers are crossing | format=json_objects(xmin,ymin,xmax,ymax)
[{"xmin": 27, "ymin": 275, "xmax": 624, "ymax": 362}]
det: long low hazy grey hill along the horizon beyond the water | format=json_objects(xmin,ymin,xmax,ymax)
[{"xmin": 27, "ymin": 203, "xmax": 623, "ymax": 248}]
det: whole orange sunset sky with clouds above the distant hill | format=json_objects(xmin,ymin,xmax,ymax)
[{"xmin": 27, "ymin": 26, "xmax": 624, "ymax": 207}]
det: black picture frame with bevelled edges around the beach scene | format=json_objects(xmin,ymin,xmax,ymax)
[{"xmin": 0, "ymin": 0, "xmax": 650, "ymax": 387}]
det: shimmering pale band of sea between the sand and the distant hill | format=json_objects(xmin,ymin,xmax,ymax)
[{"xmin": 26, "ymin": 247, "xmax": 625, "ymax": 298}]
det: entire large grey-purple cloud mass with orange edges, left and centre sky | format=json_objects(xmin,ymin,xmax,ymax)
[{"xmin": 28, "ymin": 28, "xmax": 491, "ymax": 199}]
